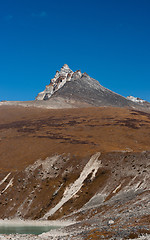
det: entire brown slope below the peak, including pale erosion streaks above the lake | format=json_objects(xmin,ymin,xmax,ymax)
[{"xmin": 0, "ymin": 106, "xmax": 150, "ymax": 239}]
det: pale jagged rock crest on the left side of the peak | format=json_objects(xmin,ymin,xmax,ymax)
[{"xmin": 36, "ymin": 64, "xmax": 74, "ymax": 100}]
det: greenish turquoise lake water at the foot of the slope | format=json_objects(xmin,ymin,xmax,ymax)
[{"xmin": 0, "ymin": 225, "xmax": 58, "ymax": 235}]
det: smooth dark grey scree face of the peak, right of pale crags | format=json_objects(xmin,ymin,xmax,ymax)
[{"xmin": 52, "ymin": 73, "xmax": 134, "ymax": 107}]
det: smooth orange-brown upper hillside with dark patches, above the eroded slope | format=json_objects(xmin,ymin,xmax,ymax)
[{"xmin": 0, "ymin": 106, "xmax": 150, "ymax": 171}]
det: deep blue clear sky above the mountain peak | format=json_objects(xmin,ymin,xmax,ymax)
[{"xmin": 0, "ymin": 0, "xmax": 150, "ymax": 101}]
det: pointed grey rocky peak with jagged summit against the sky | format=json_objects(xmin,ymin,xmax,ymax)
[{"xmin": 36, "ymin": 64, "xmax": 150, "ymax": 111}]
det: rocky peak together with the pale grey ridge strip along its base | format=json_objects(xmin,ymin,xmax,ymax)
[{"xmin": 0, "ymin": 64, "xmax": 150, "ymax": 112}]
